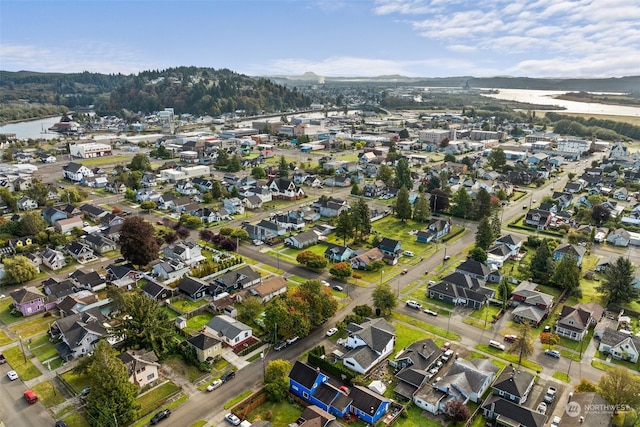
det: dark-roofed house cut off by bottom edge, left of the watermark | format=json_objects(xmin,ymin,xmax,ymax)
[{"xmin": 481, "ymin": 394, "xmax": 548, "ymax": 427}]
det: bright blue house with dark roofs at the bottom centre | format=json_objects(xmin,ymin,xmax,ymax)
[{"xmin": 289, "ymin": 361, "xmax": 391, "ymax": 424}]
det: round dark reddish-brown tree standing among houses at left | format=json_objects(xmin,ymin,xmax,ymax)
[{"xmin": 120, "ymin": 216, "xmax": 160, "ymax": 266}]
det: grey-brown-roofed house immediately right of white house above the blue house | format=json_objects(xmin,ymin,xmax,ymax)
[{"xmin": 389, "ymin": 338, "xmax": 442, "ymax": 405}]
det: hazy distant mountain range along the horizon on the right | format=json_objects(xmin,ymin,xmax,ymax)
[{"xmin": 262, "ymin": 71, "xmax": 640, "ymax": 92}]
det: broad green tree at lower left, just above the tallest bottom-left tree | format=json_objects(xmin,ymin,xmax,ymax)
[{"xmin": 115, "ymin": 292, "xmax": 175, "ymax": 357}]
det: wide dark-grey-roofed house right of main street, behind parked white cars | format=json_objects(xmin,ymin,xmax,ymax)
[{"xmin": 427, "ymin": 272, "xmax": 495, "ymax": 309}]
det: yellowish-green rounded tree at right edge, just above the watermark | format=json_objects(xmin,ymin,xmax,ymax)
[{"xmin": 598, "ymin": 366, "xmax": 640, "ymax": 409}]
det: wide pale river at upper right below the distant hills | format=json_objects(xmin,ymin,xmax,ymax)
[{"xmin": 485, "ymin": 89, "xmax": 640, "ymax": 117}]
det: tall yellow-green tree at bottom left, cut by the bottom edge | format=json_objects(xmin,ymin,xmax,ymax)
[{"xmin": 85, "ymin": 340, "xmax": 140, "ymax": 427}]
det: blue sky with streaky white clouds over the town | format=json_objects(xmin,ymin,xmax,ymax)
[{"xmin": 0, "ymin": 0, "xmax": 640, "ymax": 77}]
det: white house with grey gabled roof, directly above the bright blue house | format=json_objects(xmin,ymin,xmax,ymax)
[{"xmin": 342, "ymin": 318, "xmax": 396, "ymax": 374}]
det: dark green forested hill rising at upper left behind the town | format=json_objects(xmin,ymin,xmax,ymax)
[{"xmin": 0, "ymin": 67, "xmax": 311, "ymax": 121}]
